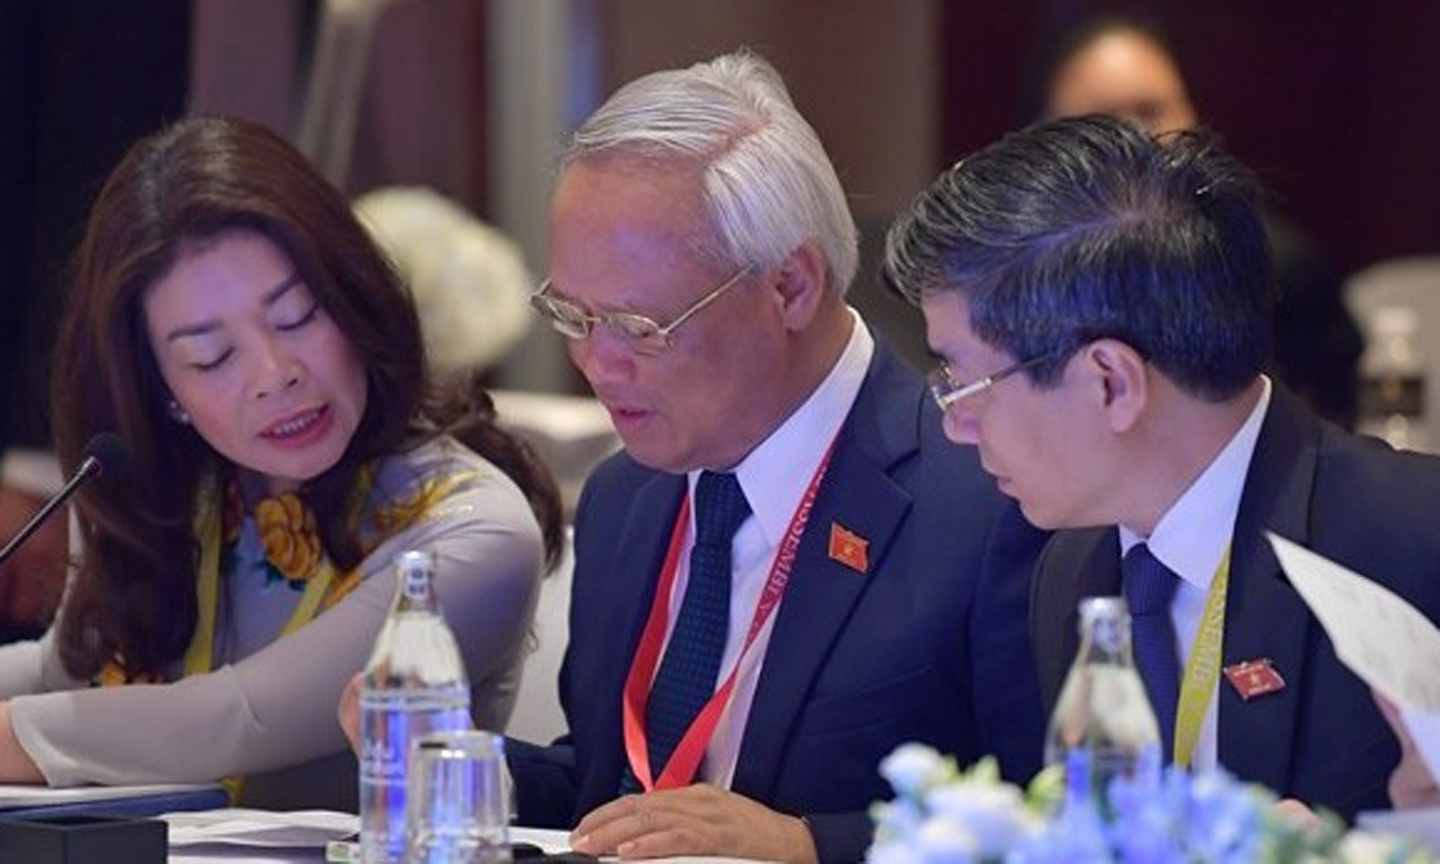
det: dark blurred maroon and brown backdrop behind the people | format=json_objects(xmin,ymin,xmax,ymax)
[{"xmin": 0, "ymin": 0, "xmax": 1440, "ymax": 641}]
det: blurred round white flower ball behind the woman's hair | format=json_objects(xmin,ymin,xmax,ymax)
[{"xmin": 354, "ymin": 186, "xmax": 533, "ymax": 377}]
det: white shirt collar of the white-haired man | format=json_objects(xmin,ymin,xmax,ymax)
[{"xmin": 688, "ymin": 308, "xmax": 876, "ymax": 547}]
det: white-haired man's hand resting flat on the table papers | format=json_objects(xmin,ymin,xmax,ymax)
[{"xmin": 570, "ymin": 783, "xmax": 816, "ymax": 863}]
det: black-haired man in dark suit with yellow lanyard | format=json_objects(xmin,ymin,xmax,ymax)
[{"xmin": 886, "ymin": 115, "xmax": 1440, "ymax": 816}]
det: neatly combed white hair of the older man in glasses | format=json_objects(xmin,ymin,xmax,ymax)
[{"xmin": 560, "ymin": 49, "xmax": 858, "ymax": 294}]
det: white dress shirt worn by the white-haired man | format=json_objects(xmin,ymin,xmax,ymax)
[{"xmin": 657, "ymin": 310, "xmax": 876, "ymax": 788}]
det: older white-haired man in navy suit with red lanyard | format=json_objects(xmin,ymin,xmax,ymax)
[{"xmin": 510, "ymin": 52, "xmax": 1043, "ymax": 861}]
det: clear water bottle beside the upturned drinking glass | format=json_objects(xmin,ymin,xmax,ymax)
[{"xmin": 360, "ymin": 552, "xmax": 471, "ymax": 864}]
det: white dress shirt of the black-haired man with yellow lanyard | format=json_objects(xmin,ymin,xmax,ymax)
[{"xmin": 1120, "ymin": 376, "xmax": 1270, "ymax": 770}]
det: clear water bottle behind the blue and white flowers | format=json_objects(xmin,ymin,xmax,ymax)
[{"xmin": 1045, "ymin": 598, "xmax": 1164, "ymax": 814}]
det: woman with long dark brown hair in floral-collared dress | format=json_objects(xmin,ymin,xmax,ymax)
[{"xmin": 0, "ymin": 118, "xmax": 557, "ymax": 804}]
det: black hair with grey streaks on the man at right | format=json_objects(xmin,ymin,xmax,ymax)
[{"xmin": 884, "ymin": 115, "xmax": 1274, "ymax": 400}]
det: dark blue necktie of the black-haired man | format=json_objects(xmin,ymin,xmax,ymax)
[{"xmin": 1120, "ymin": 543, "xmax": 1179, "ymax": 763}]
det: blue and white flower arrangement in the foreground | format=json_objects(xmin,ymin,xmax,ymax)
[{"xmin": 865, "ymin": 744, "xmax": 1434, "ymax": 864}]
